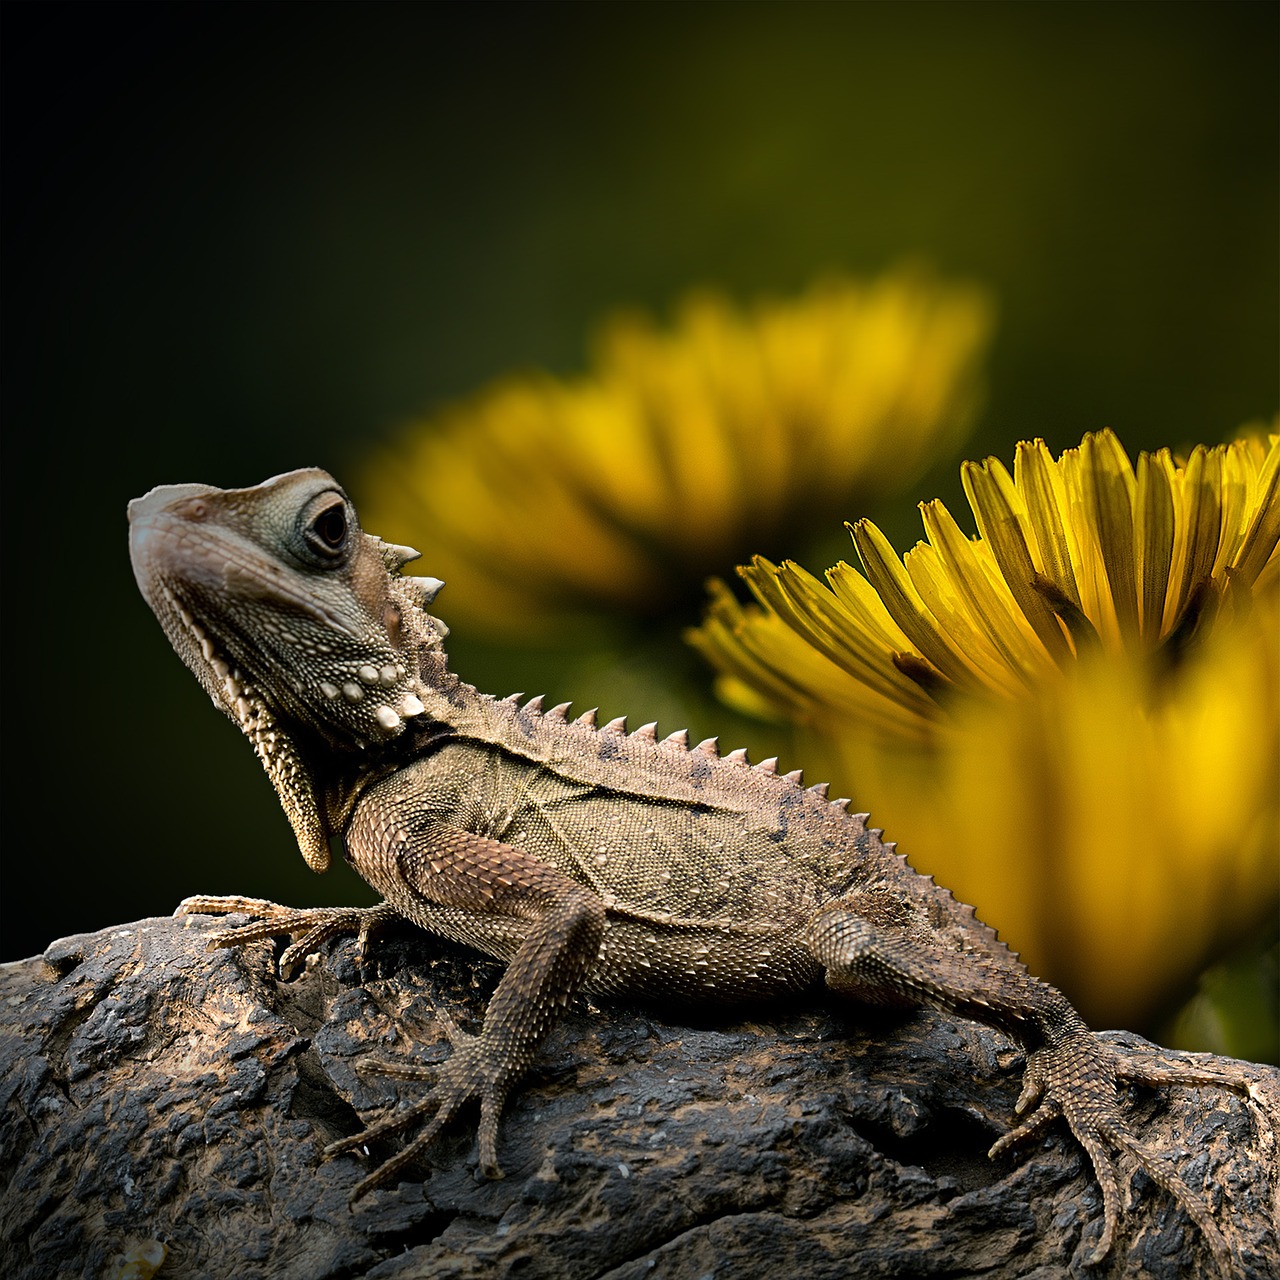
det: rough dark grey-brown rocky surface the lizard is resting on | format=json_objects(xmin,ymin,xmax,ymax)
[{"xmin": 0, "ymin": 918, "xmax": 1280, "ymax": 1280}]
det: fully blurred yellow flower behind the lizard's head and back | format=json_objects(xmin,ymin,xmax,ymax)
[{"xmin": 357, "ymin": 273, "xmax": 991, "ymax": 645}]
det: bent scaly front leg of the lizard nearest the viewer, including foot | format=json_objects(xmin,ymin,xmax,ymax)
[{"xmin": 325, "ymin": 815, "xmax": 604, "ymax": 1201}]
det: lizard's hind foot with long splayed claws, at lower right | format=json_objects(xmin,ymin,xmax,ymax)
[{"xmin": 989, "ymin": 1030, "xmax": 1242, "ymax": 1275}]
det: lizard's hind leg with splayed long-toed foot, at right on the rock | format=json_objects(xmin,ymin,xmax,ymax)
[{"xmin": 806, "ymin": 902, "xmax": 1239, "ymax": 1275}]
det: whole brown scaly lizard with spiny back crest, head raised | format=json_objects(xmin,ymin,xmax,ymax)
[{"xmin": 128, "ymin": 468, "xmax": 1240, "ymax": 1272}]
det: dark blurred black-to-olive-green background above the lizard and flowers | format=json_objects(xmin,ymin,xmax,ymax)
[{"xmin": 0, "ymin": 3, "xmax": 1280, "ymax": 959}]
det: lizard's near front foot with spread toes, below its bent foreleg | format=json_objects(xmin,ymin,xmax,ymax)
[{"xmin": 324, "ymin": 1010, "xmax": 517, "ymax": 1204}]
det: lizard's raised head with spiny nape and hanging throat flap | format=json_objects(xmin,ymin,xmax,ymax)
[{"xmin": 129, "ymin": 470, "xmax": 443, "ymax": 870}]
